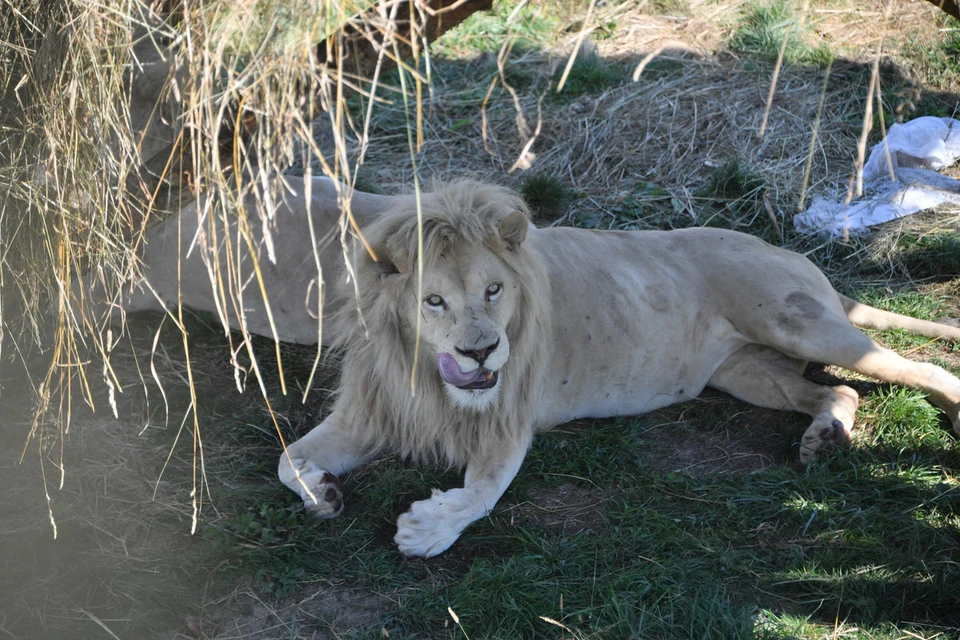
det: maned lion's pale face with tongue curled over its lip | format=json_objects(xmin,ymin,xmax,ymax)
[{"xmin": 408, "ymin": 243, "xmax": 520, "ymax": 411}]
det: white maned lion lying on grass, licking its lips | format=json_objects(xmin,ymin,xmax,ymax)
[{"xmin": 278, "ymin": 181, "xmax": 960, "ymax": 557}]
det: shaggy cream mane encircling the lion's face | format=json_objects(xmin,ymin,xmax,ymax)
[{"xmin": 334, "ymin": 181, "xmax": 550, "ymax": 467}]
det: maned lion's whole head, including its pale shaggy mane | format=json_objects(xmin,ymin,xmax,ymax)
[{"xmin": 339, "ymin": 182, "xmax": 549, "ymax": 463}]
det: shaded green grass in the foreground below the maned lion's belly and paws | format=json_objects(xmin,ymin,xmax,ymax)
[{"xmin": 184, "ymin": 342, "xmax": 960, "ymax": 640}]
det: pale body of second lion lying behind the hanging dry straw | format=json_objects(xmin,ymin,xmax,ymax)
[{"xmin": 73, "ymin": 176, "xmax": 395, "ymax": 344}]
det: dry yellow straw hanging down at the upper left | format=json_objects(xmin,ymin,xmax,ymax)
[{"xmin": 0, "ymin": 0, "xmax": 382, "ymax": 527}]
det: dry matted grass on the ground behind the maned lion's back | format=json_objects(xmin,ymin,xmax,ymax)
[{"xmin": 354, "ymin": 3, "xmax": 960, "ymax": 242}]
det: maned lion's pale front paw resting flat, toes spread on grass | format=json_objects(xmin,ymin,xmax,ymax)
[{"xmin": 393, "ymin": 489, "xmax": 475, "ymax": 558}]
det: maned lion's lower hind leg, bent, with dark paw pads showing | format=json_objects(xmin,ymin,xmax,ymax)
[{"xmin": 707, "ymin": 344, "xmax": 860, "ymax": 464}]
